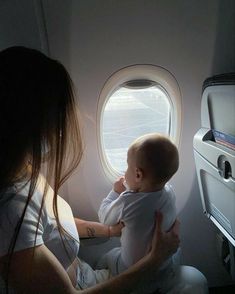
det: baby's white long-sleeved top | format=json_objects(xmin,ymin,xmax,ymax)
[{"xmin": 98, "ymin": 184, "xmax": 176, "ymax": 274}]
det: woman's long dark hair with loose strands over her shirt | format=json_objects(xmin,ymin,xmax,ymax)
[{"xmin": 0, "ymin": 47, "xmax": 82, "ymax": 290}]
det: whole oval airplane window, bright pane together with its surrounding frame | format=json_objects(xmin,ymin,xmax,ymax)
[{"xmin": 97, "ymin": 65, "xmax": 181, "ymax": 181}]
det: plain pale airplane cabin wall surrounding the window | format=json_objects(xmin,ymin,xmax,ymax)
[{"xmin": 0, "ymin": 0, "xmax": 235, "ymax": 286}]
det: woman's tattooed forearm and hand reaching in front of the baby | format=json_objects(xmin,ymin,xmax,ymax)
[{"xmin": 74, "ymin": 218, "xmax": 124, "ymax": 238}]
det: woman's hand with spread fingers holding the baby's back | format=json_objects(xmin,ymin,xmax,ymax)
[{"xmin": 150, "ymin": 212, "xmax": 180, "ymax": 261}]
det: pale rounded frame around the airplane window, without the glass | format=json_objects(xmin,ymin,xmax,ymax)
[{"xmin": 96, "ymin": 64, "xmax": 182, "ymax": 182}]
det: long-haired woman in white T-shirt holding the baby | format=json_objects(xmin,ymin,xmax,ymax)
[{"xmin": 0, "ymin": 47, "xmax": 195, "ymax": 293}]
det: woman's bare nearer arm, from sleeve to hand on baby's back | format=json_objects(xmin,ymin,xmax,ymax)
[{"xmin": 0, "ymin": 214, "xmax": 179, "ymax": 294}]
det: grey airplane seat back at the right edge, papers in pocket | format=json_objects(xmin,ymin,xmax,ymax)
[{"xmin": 193, "ymin": 73, "xmax": 235, "ymax": 280}]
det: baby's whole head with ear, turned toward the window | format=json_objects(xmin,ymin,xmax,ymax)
[{"xmin": 125, "ymin": 133, "xmax": 179, "ymax": 192}]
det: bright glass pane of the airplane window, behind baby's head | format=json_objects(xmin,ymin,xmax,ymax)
[{"xmin": 102, "ymin": 81, "xmax": 170, "ymax": 174}]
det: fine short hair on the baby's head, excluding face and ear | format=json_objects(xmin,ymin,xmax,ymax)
[{"xmin": 129, "ymin": 133, "xmax": 179, "ymax": 183}]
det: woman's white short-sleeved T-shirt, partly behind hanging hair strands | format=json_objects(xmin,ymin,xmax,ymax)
[{"xmin": 0, "ymin": 176, "xmax": 79, "ymax": 270}]
